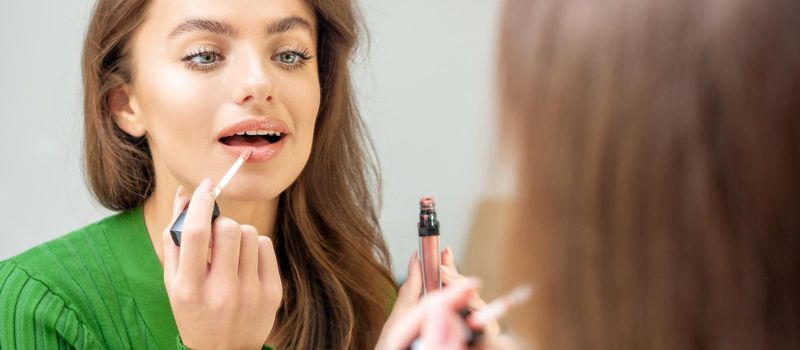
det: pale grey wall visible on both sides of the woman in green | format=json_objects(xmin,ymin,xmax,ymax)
[{"xmin": 0, "ymin": 0, "xmax": 499, "ymax": 276}]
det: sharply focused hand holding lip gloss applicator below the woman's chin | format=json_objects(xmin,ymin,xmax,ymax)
[{"xmin": 162, "ymin": 179, "xmax": 283, "ymax": 349}]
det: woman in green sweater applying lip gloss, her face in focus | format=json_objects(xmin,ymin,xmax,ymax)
[{"xmin": 0, "ymin": 0, "xmax": 395, "ymax": 349}]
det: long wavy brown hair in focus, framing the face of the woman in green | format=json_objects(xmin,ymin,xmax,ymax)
[{"xmin": 82, "ymin": 0, "xmax": 395, "ymax": 349}]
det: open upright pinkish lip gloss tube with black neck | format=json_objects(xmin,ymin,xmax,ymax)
[{"xmin": 417, "ymin": 197, "xmax": 442, "ymax": 294}]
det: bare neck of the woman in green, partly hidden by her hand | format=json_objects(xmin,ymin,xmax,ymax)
[{"xmin": 143, "ymin": 184, "xmax": 278, "ymax": 262}]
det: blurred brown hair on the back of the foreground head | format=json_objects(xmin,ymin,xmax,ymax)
[{"xmin": 499, "ymin": 0, "xmax": 800, "ymax": 349}]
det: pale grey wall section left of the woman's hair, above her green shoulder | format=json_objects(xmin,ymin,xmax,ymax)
[{"xmin": 0, "ymin": 0, "xmax": 109, "ymax": 259}]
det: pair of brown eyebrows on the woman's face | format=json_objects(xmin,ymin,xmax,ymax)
[{"xmin": 167, "ymin": 16, "xmax": 314, "ymax": 39}]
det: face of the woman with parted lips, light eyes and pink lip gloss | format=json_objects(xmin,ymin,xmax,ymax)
[{"xmin": 122, "ymin": 0, "xmax": 320, "ymax": 200}]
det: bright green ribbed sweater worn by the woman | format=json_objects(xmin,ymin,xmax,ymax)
[{"xmin": 0, "ymin": 208, "xmax": 276, "ymax": 349}]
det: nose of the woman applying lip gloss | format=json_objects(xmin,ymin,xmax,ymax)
[{"xmin": 234, "ymin": 57, "xmax": 275, "ymax": 104}]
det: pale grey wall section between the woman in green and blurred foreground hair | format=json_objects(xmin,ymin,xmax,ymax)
[{"xmin": 357, "ymin": 0, "xmax": 500, "ymax": 275}]
